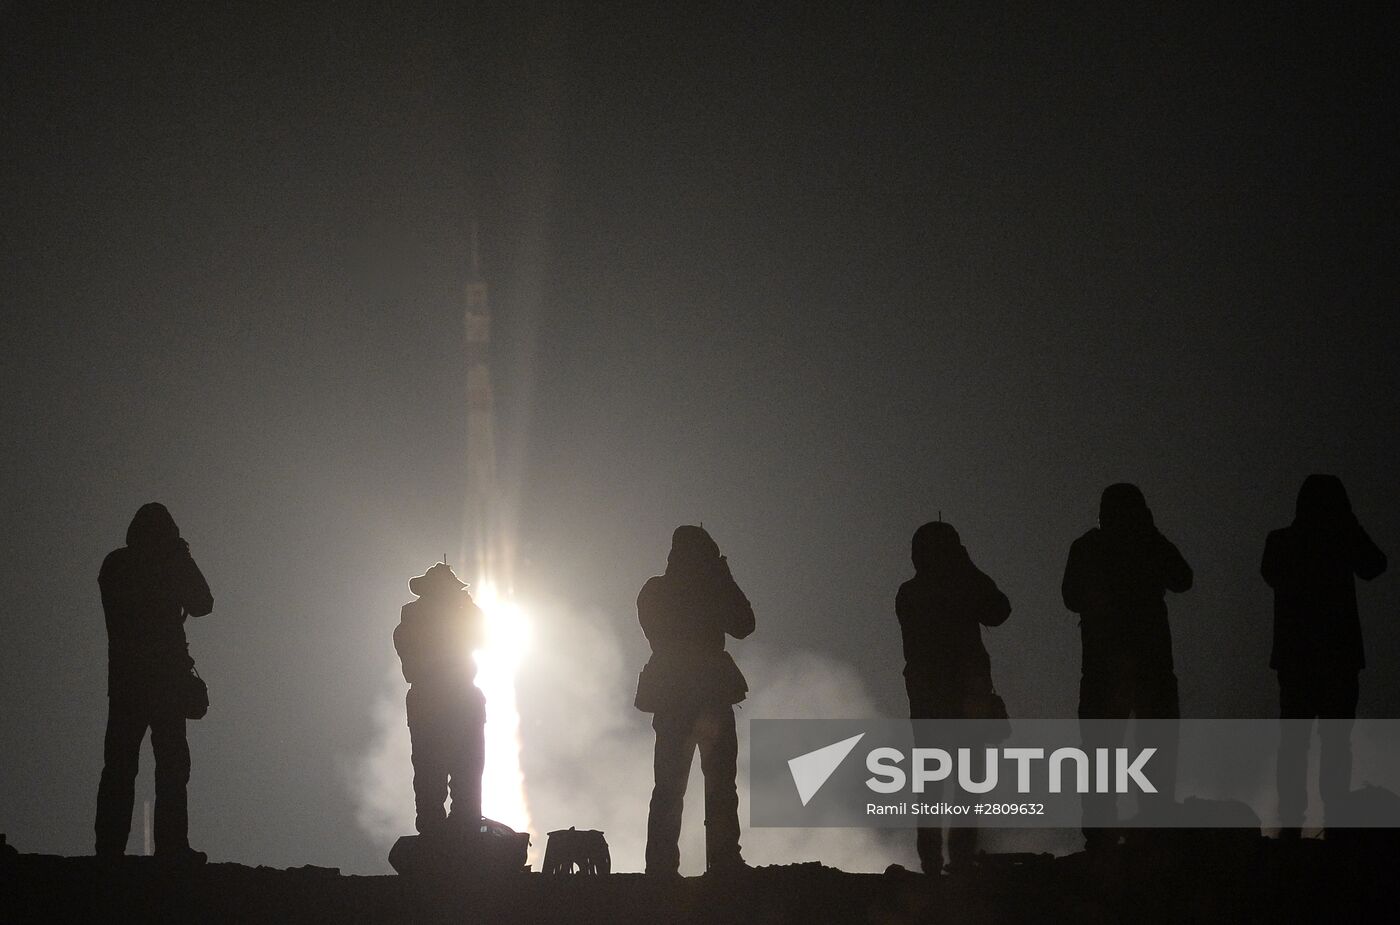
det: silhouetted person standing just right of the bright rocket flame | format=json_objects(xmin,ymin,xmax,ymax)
[{"xmin": 636, "ymin": 526, "xmax": 753, "ymax": 876}]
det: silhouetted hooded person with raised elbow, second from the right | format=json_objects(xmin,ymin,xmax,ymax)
[{"xmin": 1060, "ymin": 483, "xmax": 1193, "ymax": 849}]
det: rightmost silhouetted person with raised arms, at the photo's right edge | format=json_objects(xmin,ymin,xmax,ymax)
[{"xmin": 1260, "ymin": 474, "xmax": 1386, "ymax": 840}]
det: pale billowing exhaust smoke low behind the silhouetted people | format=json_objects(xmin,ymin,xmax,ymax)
[{"xmin": 353, "ymin": 590, "xmax": 1078, "ymax": 873}]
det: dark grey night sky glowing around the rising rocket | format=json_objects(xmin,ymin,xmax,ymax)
[{"xmin": 0, "ymin": 3, "xmax": 1400, "ymax": 869}]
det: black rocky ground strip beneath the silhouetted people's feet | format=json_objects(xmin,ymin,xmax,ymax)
[{"xmin": 0, "ymin": 831, "xmax": 1400, "ymax": 924}]
